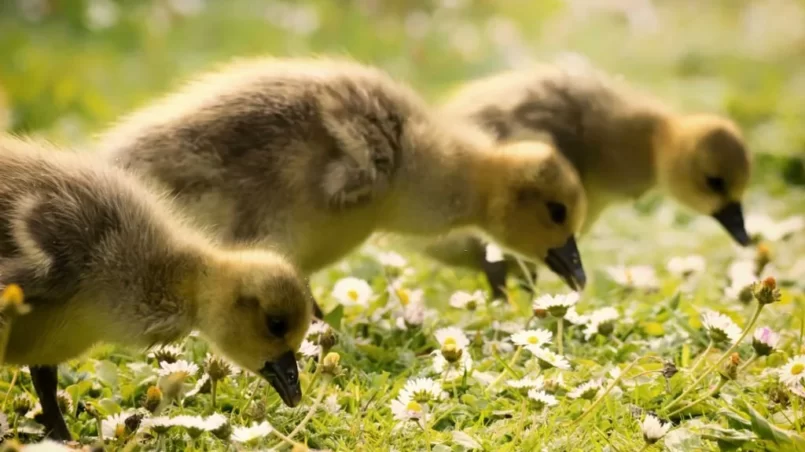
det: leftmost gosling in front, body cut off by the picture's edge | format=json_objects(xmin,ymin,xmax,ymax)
[{"xmin": 0, "ymin": 137, "xmax": 312, "ymax": 439}]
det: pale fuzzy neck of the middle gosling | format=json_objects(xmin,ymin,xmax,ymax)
[{"xmin": 380, "ymin": 121, "xmax": 494, "ymax": 235}]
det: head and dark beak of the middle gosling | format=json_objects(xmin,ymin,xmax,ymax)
[{"xmin": 481, "ymin": 141, "xmax": 587, "ymax": 290}]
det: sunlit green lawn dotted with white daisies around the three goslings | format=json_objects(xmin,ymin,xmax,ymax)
[{"xmin": 0, "ymin": 0, "xmax": 805, "ymax": 452}]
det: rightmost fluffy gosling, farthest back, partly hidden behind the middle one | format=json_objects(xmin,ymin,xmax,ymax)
[{"xmin": 426, "ymin": 64, "xmax": 751, "ymax": 296}]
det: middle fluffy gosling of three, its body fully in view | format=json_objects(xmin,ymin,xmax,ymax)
[{"xmin": 98, "ymin": 58, "xmax": 586, "ymax": 294}]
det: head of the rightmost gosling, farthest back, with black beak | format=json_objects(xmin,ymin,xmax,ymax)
[{"xmin": 658, "ymin": 115, "xmax": 751, "ymax": 246}]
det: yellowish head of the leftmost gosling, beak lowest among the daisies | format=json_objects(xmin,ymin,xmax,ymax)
[{"xmin": 198, "ymin": 251, "xmax": 313, "ymax": 406}]
